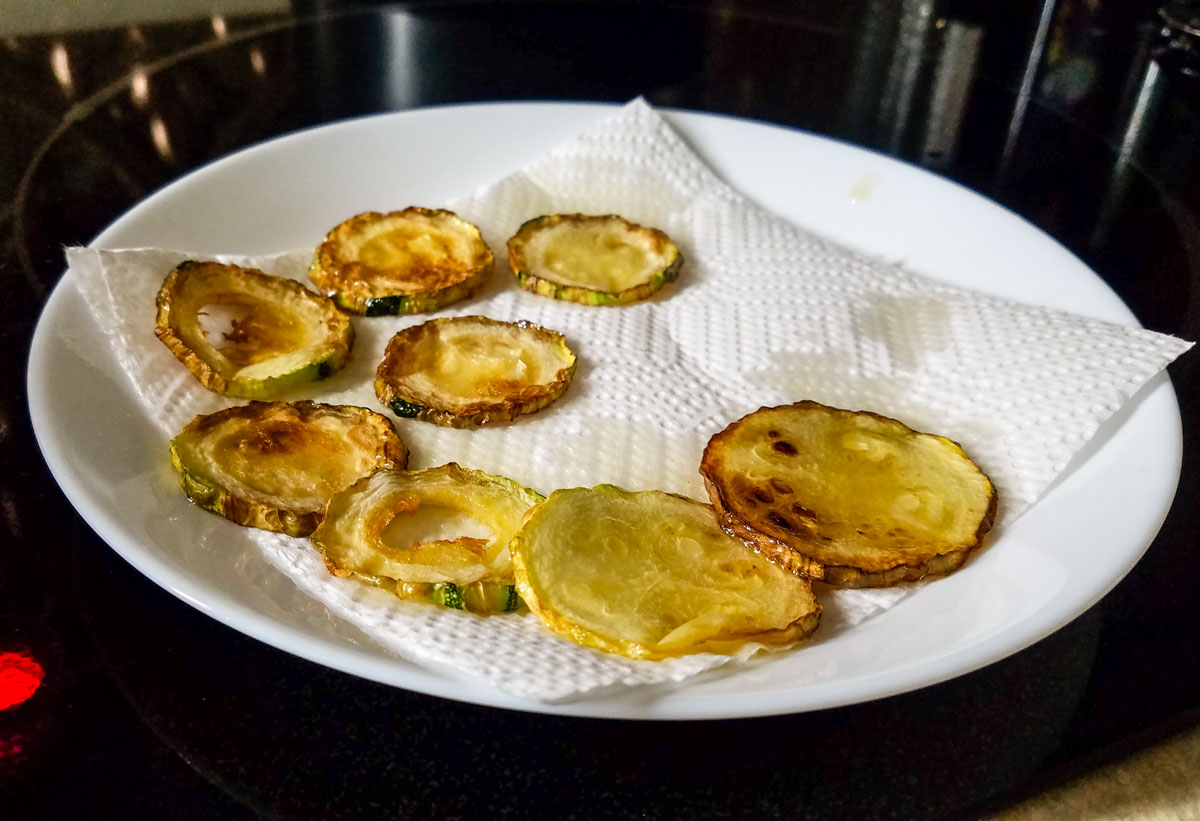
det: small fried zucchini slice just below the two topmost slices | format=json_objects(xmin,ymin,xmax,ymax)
[{"xmin": 374, "ymin": 317, "xmax": 575, "ymax": 427}]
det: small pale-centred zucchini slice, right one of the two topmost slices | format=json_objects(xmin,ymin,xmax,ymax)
[{"xmin": 509, "ymin": 214, "xmax": 683, "ymax": 305}]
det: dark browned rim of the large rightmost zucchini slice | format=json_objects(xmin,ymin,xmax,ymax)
[{"xmin": 700, "ymin": 400, "xmax": 998, "ymax": 588}]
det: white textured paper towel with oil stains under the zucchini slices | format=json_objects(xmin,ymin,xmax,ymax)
[{"xmin": 68, "ymin": 100, "xmax": 1190, "ymax": 702}]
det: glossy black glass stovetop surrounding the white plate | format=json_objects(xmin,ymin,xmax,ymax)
[{"xmin": 0, "ymin": 0, "xmax": 1200, "ymax": 819}]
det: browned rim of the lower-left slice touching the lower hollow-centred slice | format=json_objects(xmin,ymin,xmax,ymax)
[{"xmin": 170, "ymin": 400, "xmax": 408, "ymax": 537}]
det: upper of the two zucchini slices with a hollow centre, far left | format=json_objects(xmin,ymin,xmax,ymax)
[{"xmin": 155, "ymin": 259, "xmax": 354, "ymax": 398}]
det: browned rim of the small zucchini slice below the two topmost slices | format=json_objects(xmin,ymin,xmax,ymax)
[{"xmin": 374, "ymin": 317, "xmax": 576, "ymax": 427}]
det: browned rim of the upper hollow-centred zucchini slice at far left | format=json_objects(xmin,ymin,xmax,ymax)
[{"xmin": 155, "ymin": 259, "xmax": 354, "ymax": 398}]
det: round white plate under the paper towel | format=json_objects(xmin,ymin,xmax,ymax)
[{"xmin": 29, "ymin": 103, "xmax": 1182, "ymax": 719}]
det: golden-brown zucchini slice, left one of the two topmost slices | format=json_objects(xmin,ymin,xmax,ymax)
[{"xmin": 308, "ymin": 208, "xmax": 494, "ymax": 317}]
